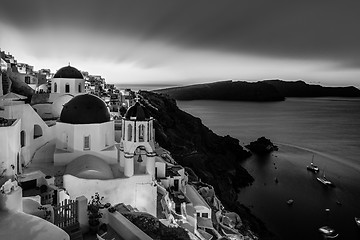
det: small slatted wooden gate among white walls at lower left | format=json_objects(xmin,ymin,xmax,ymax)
[{"xmin": 54, "ymin": 199, "xmax": 78, "ymax": 229}]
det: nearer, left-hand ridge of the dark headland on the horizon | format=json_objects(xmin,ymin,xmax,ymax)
[{"xmin": 154, "ymin": 81, "xmax": 285, "ymax": 101}]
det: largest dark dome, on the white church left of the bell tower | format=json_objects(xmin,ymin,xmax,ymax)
[{"xmin": 60, "ymin": 94, "xmax": 110, "ymax": 124}]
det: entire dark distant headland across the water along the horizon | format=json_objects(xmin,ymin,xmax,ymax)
[{"xmin": 154, "ymin": 80, "xmax": 360, "ymax": 102}]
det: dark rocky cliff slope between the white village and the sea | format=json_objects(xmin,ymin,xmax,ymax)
[{"xmin": 140, "ymin": 91, "xmax": 253, "ymax": 204}]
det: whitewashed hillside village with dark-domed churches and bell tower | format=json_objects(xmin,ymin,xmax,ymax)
[{"xmin": 0, "ymin": 52, "xmax": 257, "ymax": 240}]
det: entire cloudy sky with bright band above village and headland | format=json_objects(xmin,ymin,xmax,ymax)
[{"xmin": 0, "ymin": 0, "xmax": 360, "ymax": 87}]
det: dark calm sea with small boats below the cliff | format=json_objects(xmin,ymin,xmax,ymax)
[{"xmin": 177, "ymin": 98, "xmax": 360, "ymax": 239}]
